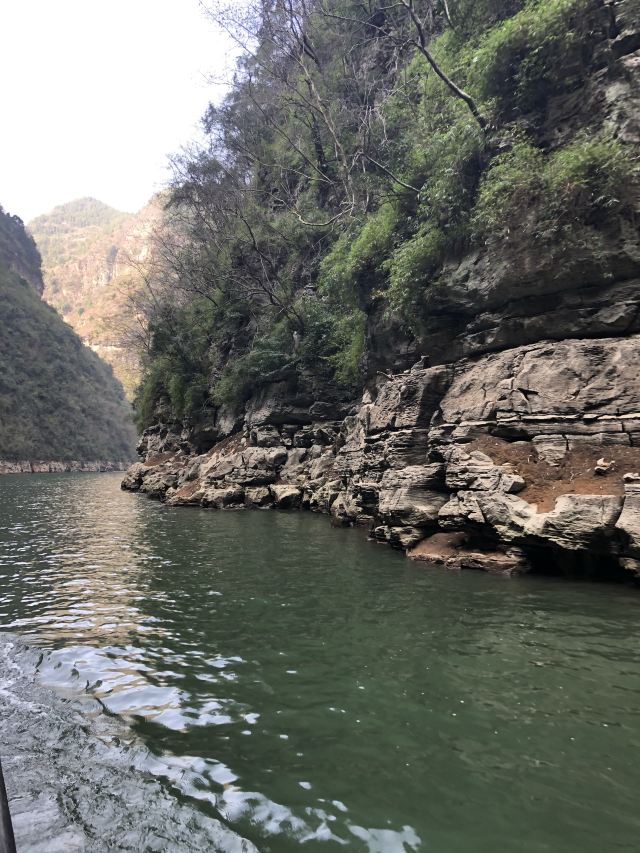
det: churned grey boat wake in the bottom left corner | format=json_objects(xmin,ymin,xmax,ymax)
[{"xmin": 0, "ymin": 634, "xmax": 256, "ymax": 853}]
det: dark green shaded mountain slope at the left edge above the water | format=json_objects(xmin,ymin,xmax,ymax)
[{"xmin": 0, "ymin": 208, "xmax": 135, "ymax": 463}]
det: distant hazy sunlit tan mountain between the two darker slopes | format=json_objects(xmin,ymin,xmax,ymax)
[{"xmin": 28, "ymin": 198, "xmax": 159, "ymax": 396}]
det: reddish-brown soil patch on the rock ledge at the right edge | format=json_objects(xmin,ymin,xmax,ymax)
[{"xmin": 469, "ymin": 436, "xmax": 640, "ymax": 512}]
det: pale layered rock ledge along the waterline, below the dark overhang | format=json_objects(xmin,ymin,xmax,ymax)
[{"xmin": 123, "ymin": 335, "xmax": 640, "ymax": 578}]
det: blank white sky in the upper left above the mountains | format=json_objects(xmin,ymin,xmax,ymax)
[{"xmin": 0, "ymin": 0, "xmax": 232, "ymax": 221}]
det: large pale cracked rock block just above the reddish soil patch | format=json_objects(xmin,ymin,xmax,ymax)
[{"xmin": 437, "ymin": 335, "xmax": 640, "ymax": 445}]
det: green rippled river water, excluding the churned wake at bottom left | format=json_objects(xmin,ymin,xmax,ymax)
[{"xmin": 0, "ymin": 475, "xmax": 640, "ymax": 853}]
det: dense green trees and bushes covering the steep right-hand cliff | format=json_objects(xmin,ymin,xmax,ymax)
[{"xmin": 138, "ymin": 0, "xmax": 638, "ymax": 425}]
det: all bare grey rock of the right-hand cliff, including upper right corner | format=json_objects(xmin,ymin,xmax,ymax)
[{"xmin": 123, "ymin": 0, "xmax": 640, "ymax": 578}]
